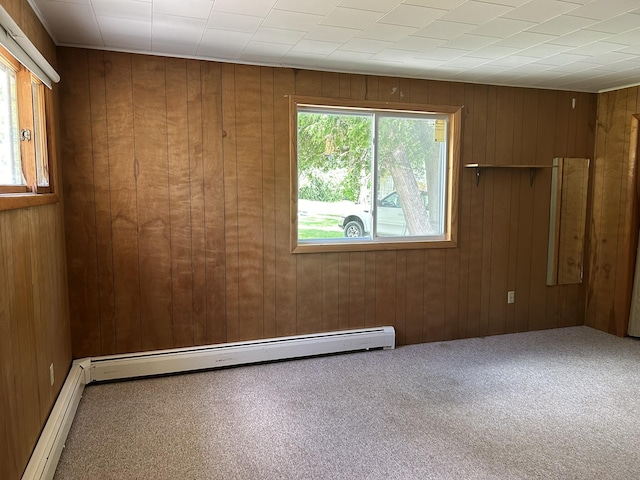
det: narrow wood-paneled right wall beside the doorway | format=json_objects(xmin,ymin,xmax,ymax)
[{"xmin": 586, "ymin": 87, "xmax": 640, "ymax": 336}]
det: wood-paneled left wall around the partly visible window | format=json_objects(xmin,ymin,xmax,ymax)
[{"xmin": 0, "ymin": 0, "xmax": 71, "ymax": 480}]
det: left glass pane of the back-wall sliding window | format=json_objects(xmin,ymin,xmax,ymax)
[{"xmin": 297, "ymin": 109, "xmax": 373, "ymax": 242}]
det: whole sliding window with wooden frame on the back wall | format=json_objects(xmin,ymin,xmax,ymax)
[{"xmin": 291, "ymin": 97, "xmax": 461, "ymax": 253}]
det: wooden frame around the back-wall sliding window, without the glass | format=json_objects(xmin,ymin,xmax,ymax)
[{"xmin": 289, "ymin": 95, "xmax": 463, "ymax": 253}]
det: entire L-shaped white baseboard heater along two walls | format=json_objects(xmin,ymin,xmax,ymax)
[{"xmin": 22, "ymin": 327, "xmax": 396, "ymax": 480}]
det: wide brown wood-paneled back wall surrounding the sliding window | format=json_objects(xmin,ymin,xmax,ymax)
[{"xmin": 59, "ymin": 48, "xmax": 596, "ymax": 357}]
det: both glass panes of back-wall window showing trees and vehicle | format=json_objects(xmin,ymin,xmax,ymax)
[{"xmin": 297, "ymin": 107, "xmax": 448, "ymax": 242}]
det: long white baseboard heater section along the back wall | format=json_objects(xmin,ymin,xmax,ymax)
[{"xmin": 89, "ymin": 327, "xmax": 395, "ymax": 382}]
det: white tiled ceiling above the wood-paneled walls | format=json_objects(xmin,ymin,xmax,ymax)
[{"xmin": 29, "ymin": 0, "xmax": 640, "ymax": 92}]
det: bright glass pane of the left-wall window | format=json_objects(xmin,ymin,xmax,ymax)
[{"xmin": 0, "ymin": 62, "xmax": 26, "ymax": 185}]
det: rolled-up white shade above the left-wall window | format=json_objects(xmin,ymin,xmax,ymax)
[{"xmin": 0, "ymin": 5, "xmax": 60, "ymax": 88}]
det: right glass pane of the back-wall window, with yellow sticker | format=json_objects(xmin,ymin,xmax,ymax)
[{"xmin": 374, "ymin": 114, "xmax": 447, "ymax": 237}]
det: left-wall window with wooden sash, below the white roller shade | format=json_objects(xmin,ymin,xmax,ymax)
[{"xmin": 0, "ymin": 46, "xmax": 51, "ymax": 203}]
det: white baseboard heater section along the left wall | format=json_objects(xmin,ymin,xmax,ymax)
[{"xmin": 22, "ymin": 362, "xmax": 87, "ymax": 480}]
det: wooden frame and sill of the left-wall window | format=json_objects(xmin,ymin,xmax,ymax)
[{"xmin": 0, "ymin": 45, "xmax": 58, "ymax": 211}]
